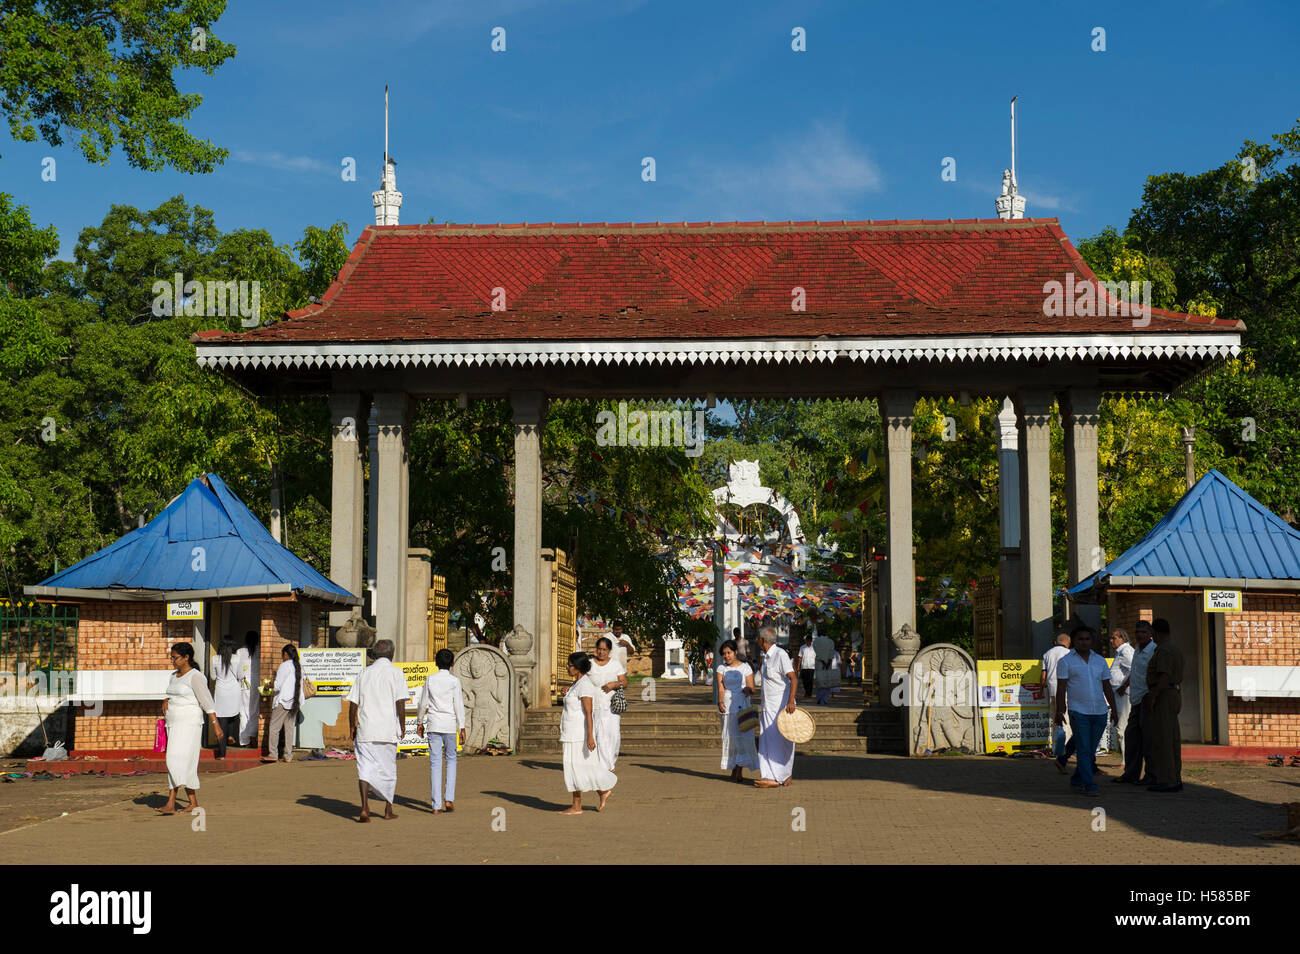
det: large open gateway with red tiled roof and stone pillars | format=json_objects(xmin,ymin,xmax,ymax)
[{"xmin": 195, "ymin": 217, "xmax": 1242, "ymax": 707}]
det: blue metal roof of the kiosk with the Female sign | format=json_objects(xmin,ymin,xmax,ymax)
[{"xmin": 23, "ymin": 474, "xmax": 360, "ymax": 606}]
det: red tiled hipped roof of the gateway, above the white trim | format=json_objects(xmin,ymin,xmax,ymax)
[{"xmin": 198, "ymin": 218, "xmax": 1240, "ymax": 344}]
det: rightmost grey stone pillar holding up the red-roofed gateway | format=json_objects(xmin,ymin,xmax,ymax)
[{"xmin": 1061, "ymin": 387, "xmax": 1105, "ymax": 637}]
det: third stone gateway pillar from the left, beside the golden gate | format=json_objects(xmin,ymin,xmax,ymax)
[{"xmin": 510, "ymin": 391, "xmax": 550, "ymax": 706}]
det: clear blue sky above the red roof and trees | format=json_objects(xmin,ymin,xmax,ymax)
[{"xmin": 0, "ymin": 0, "xmax": 1300, "ymax": 261}]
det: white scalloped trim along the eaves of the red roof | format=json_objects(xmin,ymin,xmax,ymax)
[{"xmin": 196, "ymin": 331, "xmax": 1242, "ymax": 368}]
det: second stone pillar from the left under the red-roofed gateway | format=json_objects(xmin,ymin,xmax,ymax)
[{"xmin": 374, "ymin": 391, "xmax": 410, "ymax": 646}]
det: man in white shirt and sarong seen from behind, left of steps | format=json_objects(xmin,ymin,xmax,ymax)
[{"xmin": 345, "ymin": 639, "xmax": 410, "ymax": 821}]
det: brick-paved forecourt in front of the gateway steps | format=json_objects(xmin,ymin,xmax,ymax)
[{"xmin": 0, "ymin": 755, "xmax": 1300, "ymax": 864}]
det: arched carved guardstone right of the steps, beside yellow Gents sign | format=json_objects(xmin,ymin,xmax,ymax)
[{"xmin": 904, "ymin": 642, "xmax": 984, "ymax": 755}]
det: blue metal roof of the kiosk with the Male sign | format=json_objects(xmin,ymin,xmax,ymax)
[{"xmin": 1069, "ymin": 471, "xmax": 1300, "ymax": 595}]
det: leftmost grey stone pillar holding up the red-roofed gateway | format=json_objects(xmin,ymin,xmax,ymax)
[{"xmin": 329, "ymin": 391, "xmax": 369, "ymax": 626}]
